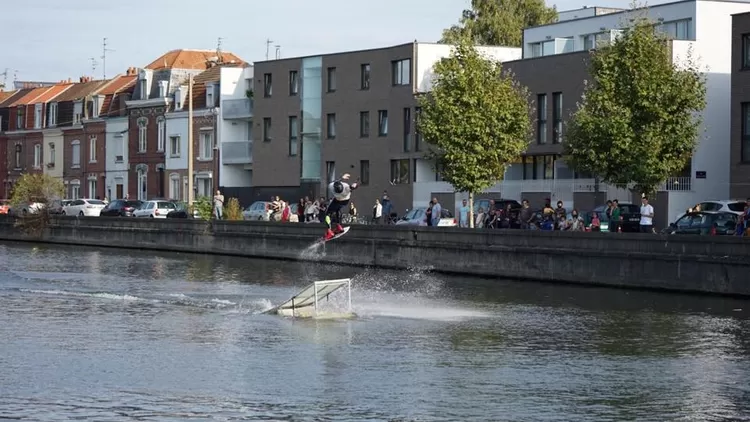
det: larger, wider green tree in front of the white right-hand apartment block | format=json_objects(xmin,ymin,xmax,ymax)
[{"xmin": 565, "ymin": 17, "xmax": 706, "ymax": 193}]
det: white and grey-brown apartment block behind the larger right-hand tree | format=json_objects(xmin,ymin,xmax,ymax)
[{"xmin": 415, "ymin": 0, "xmax": 750, "ymax": 226}]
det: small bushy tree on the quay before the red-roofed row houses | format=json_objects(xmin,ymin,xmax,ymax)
[{"xmin": 10, "ymin": 174, "xmax": 65, "ymax": 235}]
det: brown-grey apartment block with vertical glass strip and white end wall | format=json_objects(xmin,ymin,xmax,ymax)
[{"xmin": 253, "ymin": 42, "xmax": 521, "ymax": 214}]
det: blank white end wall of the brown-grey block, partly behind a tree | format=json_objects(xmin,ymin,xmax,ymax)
[{"xmin": 413, "ymin": 43, "xmax": 521, "ymax": 92}]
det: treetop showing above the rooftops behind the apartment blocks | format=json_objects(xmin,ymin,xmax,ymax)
[{"xmin": 440, "ymin": 0, "xmax": 557, "ymax": 47}]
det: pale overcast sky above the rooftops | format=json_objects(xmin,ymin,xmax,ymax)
[{"xmin": 0, "ymin": 0, "xmax": 648, "ymax": 86}]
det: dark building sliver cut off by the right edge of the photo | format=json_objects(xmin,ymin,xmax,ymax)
[{"xmin": 729, "ymin": 12, "xmax": 750, "ymax": 199}]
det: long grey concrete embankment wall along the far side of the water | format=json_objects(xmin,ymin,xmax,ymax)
[{"xmin": 0, "ymin": 217, "xmax": 750, "ymax": 297}]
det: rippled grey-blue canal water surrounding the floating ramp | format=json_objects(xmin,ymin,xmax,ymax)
[{"xmin": 0, "ymin": 243, "xmax": 750, "ymax": 421}]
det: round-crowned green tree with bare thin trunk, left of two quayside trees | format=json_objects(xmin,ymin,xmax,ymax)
[{"xmin": 418, "ymin": 40, "xmax": 531, "ymax": 227}]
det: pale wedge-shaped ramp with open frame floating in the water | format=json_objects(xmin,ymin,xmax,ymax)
[{"xmin": 266, "ymin": 278, "xmax": 354, "ymax": 318}]
